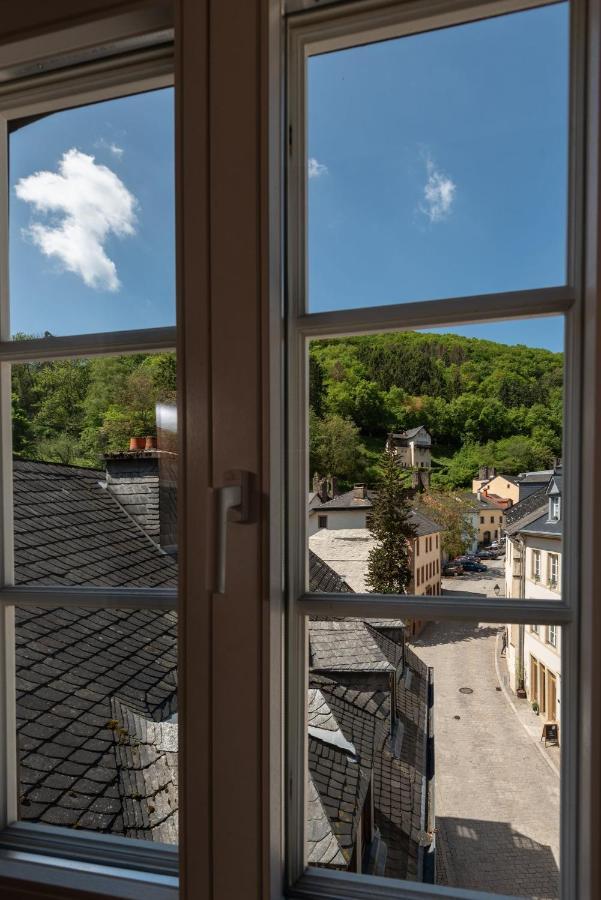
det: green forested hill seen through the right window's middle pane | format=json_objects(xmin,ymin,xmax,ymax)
[{"xmin": 310, "ymin": 324, "xmax": 563, "ymax": 487}]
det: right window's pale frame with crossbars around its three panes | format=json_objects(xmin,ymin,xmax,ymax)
[{"xmin": 284, "ymin": 0, "xmax": 584, "ymax": 900}]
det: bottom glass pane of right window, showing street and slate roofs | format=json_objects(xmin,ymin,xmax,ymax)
[{"xmin": 306, "ymin": 618, "xmax": 561, "ymax": 900}]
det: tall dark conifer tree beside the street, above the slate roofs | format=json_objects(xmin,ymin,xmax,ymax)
[{"xmin": 366, "ymin": 450, "xmax": 416, "ymax": 594}]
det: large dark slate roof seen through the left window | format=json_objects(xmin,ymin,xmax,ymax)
[{"xmin": 14, "ymin": 460, "xmax": 177, "ymax": 842}]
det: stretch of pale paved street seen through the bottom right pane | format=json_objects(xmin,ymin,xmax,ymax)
[{"xmin": 414, "ymin": 622, "xmax": 559, "ymax": 900}]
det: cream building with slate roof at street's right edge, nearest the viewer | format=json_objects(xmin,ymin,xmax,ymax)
[{"xmin": 505, "ymin": 472, "xmax": 562, "ymax": 722}]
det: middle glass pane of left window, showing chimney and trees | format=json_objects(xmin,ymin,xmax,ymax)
[{"xmin": 12, "ymin": 353, "xmax": 177, "ymax": 587}]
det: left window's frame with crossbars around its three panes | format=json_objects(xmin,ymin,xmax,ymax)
[{"xmin": 0, "ymin": 31, "xmax": 179, "ymax": 900}]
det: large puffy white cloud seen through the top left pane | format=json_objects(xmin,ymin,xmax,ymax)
[{"xmin": 15, "ymin": 148, "xmax": 136, "ymax": 291}]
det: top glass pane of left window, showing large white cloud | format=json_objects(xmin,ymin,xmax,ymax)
[{"xmin": 9, "ymin": 88, "xmax": 175, "ymax": 338}]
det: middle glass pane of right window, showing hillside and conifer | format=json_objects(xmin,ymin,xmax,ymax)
[{"xmin": 307, "ymin": 317, "xmax": 564, "ymax": 599}]
